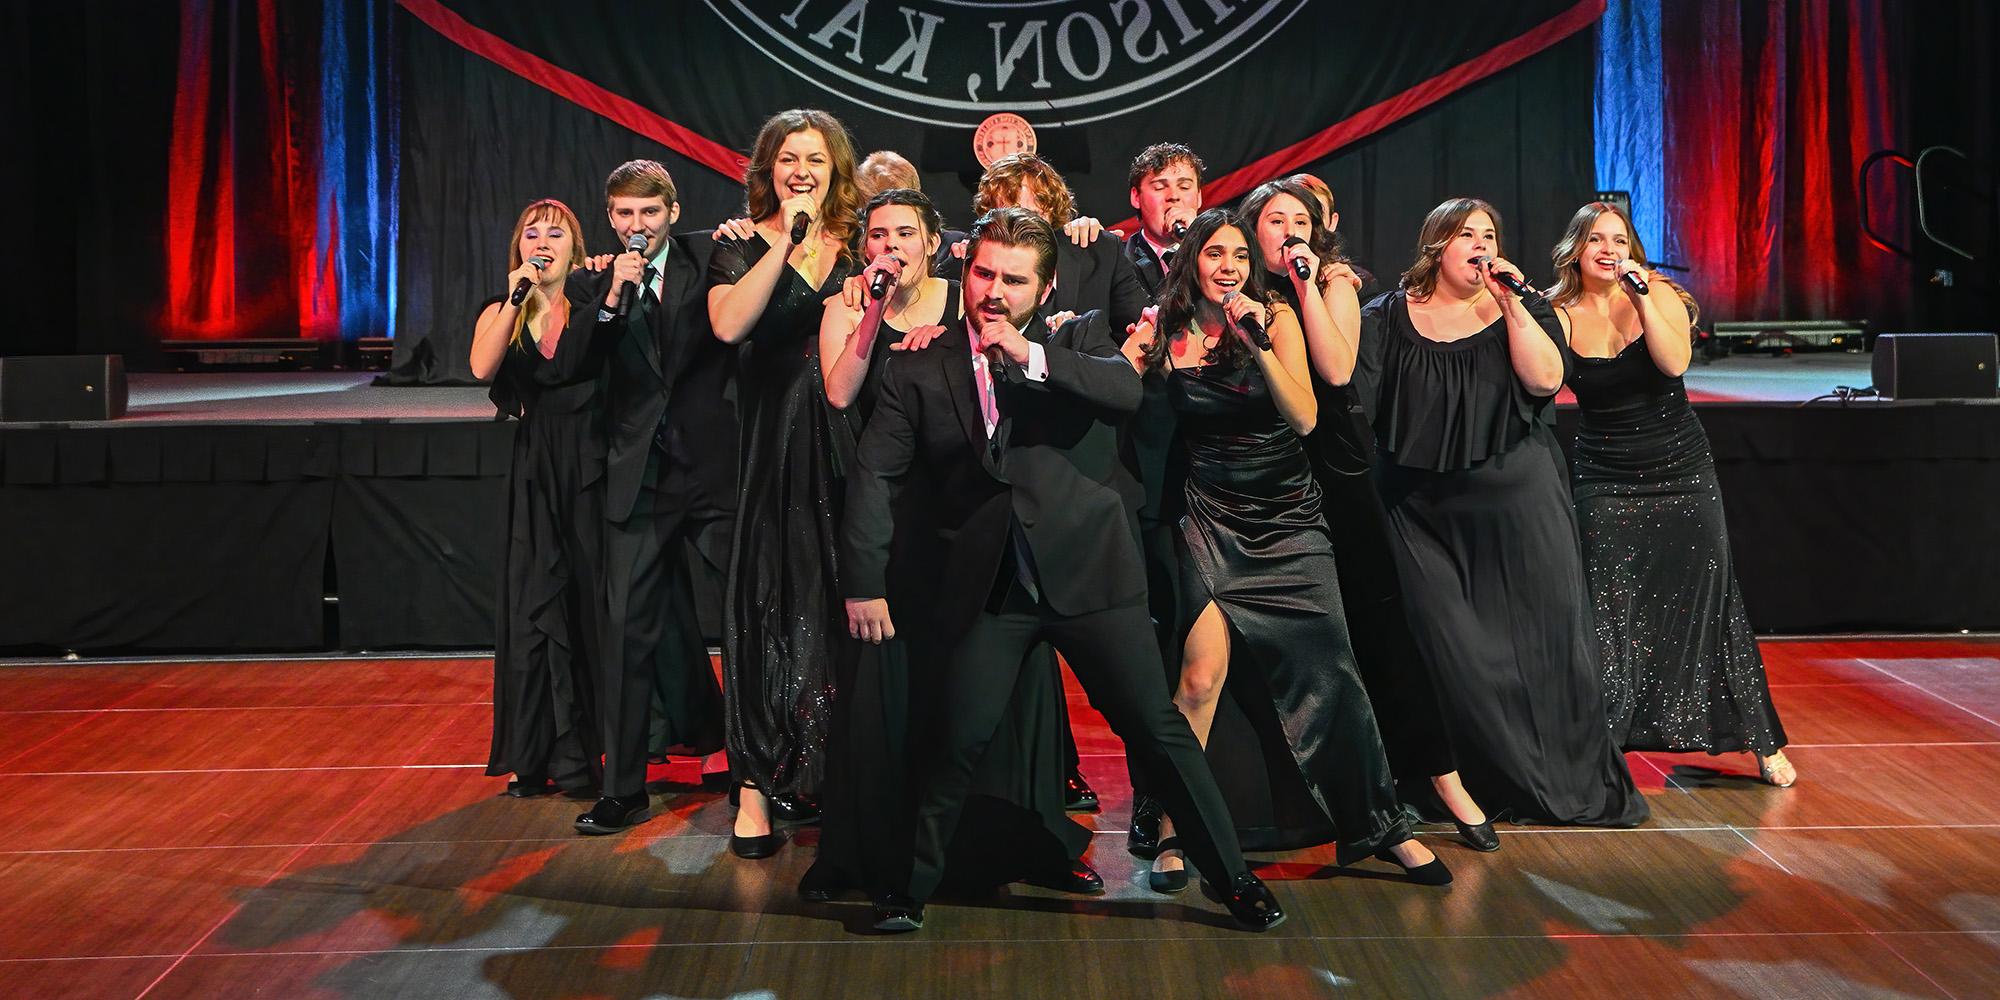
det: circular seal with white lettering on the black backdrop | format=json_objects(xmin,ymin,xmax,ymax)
[{"xmin": 704, "ymin": 0, "xmax": 1310, "ymax": 128}]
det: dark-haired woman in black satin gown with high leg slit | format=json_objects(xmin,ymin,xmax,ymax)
[{"xmin": 1124, "ymin": 208, "xmax": 1450, "ymax": 892}]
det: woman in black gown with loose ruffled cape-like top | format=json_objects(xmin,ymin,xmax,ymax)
[{"xmin": 1354, "ymin": 198, "xmax": 1648, "ymax": 826}]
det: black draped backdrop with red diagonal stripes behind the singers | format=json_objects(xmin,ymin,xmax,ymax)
[{"xmin": 396, "ymin": 0, "xmax": 1604, "ymax": 382}]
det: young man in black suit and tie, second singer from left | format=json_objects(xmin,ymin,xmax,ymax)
[{"xmin": 576, "ymin": 160, "xmax": 736, "ymax": 834}]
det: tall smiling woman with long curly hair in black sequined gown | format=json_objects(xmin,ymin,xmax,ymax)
[{"xmin": 708, "ymin": 110, "xmax": 860, "ymax": 858}]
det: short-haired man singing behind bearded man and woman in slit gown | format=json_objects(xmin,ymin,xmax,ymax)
[{"xmin": 1112, "ymin": 142, "xmax": 1202, "ymax": 858}]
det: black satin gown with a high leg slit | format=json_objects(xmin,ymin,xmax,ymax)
[{"xmin": 1166, "ymin": 348, "xmax": 1410, "ymax": 864}]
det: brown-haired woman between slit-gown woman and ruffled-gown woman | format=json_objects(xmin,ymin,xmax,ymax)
[{"xmin": 1236, "ymin": 178, "xmax": 1500, "ymax": 850}]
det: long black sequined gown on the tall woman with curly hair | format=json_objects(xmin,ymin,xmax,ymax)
[{"xmin": 708, "ymin": 236, "xmax": 856, "ymax": 798}]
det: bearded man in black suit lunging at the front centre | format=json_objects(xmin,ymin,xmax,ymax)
[{"xmin": 842, "ymin": 208, "xmax": 1284, "ymax": 930}]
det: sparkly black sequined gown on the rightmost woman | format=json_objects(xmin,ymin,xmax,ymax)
[{"xmin": 1570, "ymin": 338, "xmax": 1786, "ymax": 756}]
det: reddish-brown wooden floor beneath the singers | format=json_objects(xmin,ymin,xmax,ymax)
[{"xmin": 0, "ymin": 640, "xmax": 2000, "ymax": 1000}]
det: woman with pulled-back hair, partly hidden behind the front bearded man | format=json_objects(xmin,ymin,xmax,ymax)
[{"xmin": 800, "ymin": 188, "xmax": 1104, "ymax": 900}]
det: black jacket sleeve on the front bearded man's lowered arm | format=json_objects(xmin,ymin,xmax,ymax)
[{"xmin": 840, "ymin": 354, "xmax": 916, "ymax": 600}]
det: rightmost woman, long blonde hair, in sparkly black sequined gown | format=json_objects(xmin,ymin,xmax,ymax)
[{"xmin": 1550, "ymin": 202, "xmax": 1798, "ymax": 788}]
